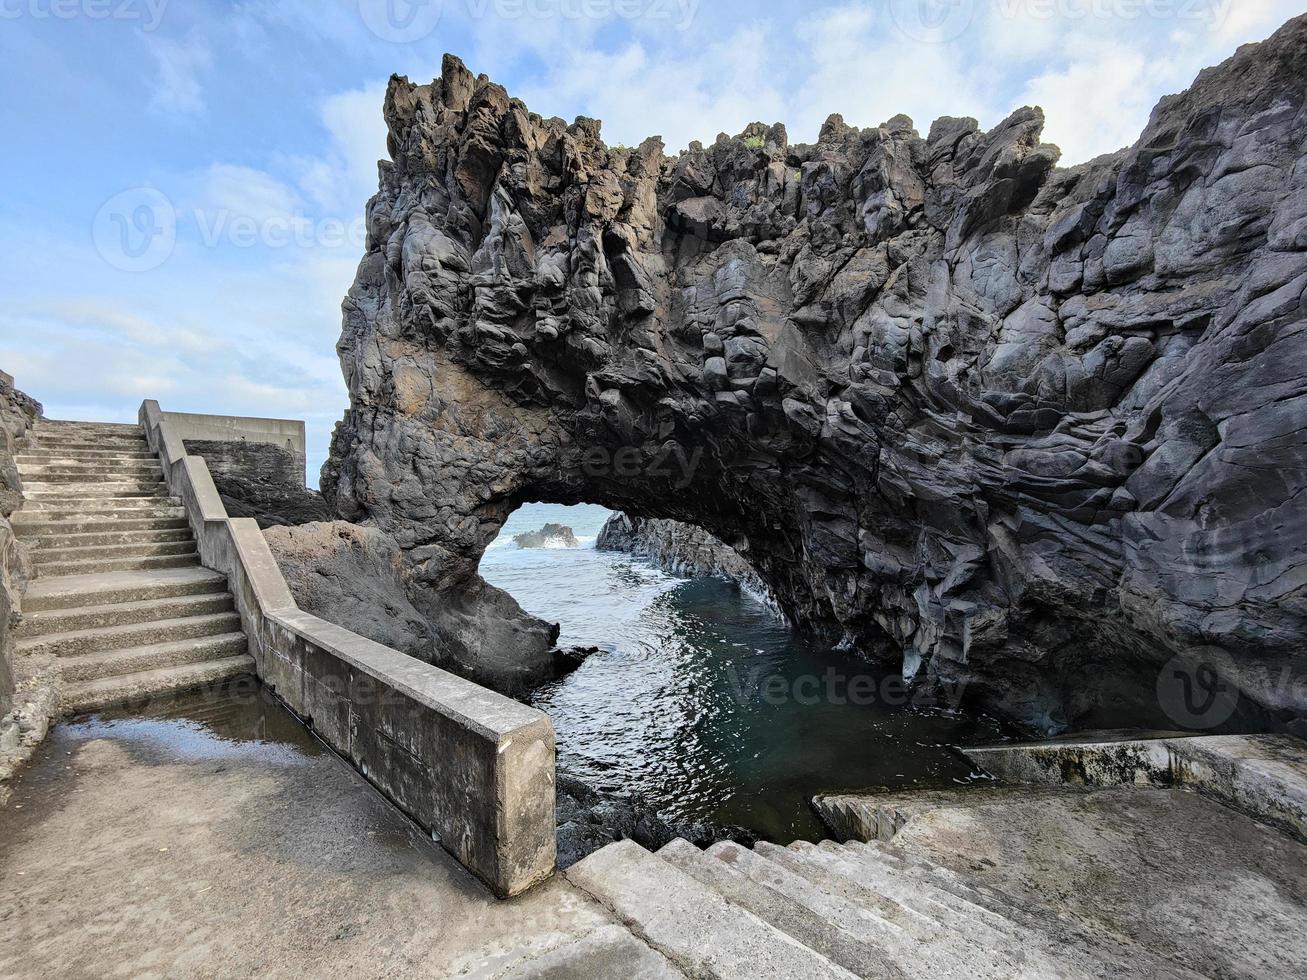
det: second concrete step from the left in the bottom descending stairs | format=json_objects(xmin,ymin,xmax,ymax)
[{"xmin": 657, "ymin": 840, "xmax": 904, "ymax": 980}]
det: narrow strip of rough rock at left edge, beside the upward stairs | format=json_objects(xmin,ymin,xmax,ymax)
[{"xmin": 0, "ymin": 374, "xmax": 41, "ymax": 736}]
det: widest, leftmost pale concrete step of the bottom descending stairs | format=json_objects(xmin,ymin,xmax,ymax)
[{"xmin": 566, "ymin": 840, "xmax": 855, "ymax": 980}]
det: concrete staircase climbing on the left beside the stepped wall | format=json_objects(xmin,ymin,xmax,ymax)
[{"xmin": 13, "ymin": 421, "xmax": 254, "ymax": 713}]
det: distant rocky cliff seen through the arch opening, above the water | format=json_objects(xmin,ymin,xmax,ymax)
[{"xmin": 595, "ymin": 514, "xmax": 779, "ymax": 608}]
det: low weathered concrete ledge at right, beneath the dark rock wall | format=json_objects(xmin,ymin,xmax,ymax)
[{"xmin": 965, "ymin": 732, "xmax": 1307, "ymax": 841}]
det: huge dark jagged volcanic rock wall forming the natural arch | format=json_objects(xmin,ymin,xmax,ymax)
[{"xmin": 323, "ymin": 17, "xmax": 1307, "ymax": 730}]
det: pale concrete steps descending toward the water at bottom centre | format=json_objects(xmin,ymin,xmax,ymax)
[{"xmin": 566, "ymin": 840, "xmax": 1195, "ymax": 980}]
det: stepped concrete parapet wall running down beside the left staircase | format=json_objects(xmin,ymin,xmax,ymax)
[{"xmin": 140, "ymin": 401, "xmax": 555, "ymax": 896}]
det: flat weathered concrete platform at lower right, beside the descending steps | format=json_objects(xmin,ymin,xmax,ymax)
[{"xmin": 882, "ymin": 788, "xmax": 1307, "ymax": 980}]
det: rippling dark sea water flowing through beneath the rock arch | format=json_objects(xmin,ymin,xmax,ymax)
[{"xmin": 481, "ymin": 504, "xmax": 1002, "ymax": 843}]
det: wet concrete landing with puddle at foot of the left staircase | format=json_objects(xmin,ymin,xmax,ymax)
[{"xmin": 0, "ymin": 689, "xmax": 648, "ymax": 977}]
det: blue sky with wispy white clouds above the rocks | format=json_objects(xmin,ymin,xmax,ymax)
[{"xmin": 0, "ymin": 0, "xmax": 1304, "ymax": 485}]
